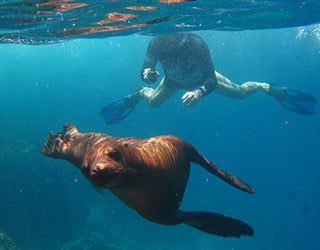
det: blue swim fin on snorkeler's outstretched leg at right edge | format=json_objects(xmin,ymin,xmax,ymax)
[{"xmin": 279, "ymin": 88, "xmax": 318, "ymax": 115}]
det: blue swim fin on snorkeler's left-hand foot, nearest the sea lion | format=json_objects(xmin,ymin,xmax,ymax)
[{"xmin": 100, "ymin": 95, "xmax": 139, "ymax": 124}]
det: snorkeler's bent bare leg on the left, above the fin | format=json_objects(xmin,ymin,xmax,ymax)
[{"xmin": 139, "ymin": 77, "xmax": 178, "ymax": 107}]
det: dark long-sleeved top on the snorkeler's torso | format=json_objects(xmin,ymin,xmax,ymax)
[{"xmin": 143, "ymin": 32, "xmax": 217, "ymax": 95}]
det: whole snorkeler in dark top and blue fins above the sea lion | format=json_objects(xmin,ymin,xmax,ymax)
[{"xmin": 101, "ymin": 32, "xmax": 317, "ymax": 123}]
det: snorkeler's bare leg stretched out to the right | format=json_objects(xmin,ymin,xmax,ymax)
[{"xmin": 214, "ymin": 72, "xmax": 285, "ymax": 99}]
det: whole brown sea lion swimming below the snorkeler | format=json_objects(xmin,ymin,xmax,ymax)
[{"xmin": 41, "ymin": 123, "xmax": 255, "ymax": 237}]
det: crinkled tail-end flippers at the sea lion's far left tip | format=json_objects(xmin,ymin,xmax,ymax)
[{"xmin": 40, "ymin": 123, "xmax": 79, "ymax": 159}]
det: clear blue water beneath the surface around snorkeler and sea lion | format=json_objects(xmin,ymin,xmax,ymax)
[{"xmin": 0, "ymin": 26, "xmax": 320, "ymax": 250}]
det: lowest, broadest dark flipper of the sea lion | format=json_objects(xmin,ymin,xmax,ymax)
[{"xmin": 178, "ymin": 212, "xmax": 254, "ymax": 238}]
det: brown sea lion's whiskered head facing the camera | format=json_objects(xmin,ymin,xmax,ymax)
[{"xmin": 81, "ymin": 140, "xmax": 135, "ymax": 189}]
